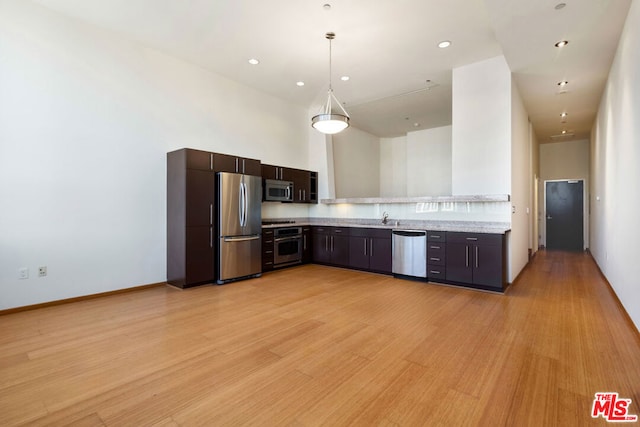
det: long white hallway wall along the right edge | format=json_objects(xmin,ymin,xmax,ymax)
[{"xmin": 590, "ymin": 1, "xmax": 640, "ymax": 329}]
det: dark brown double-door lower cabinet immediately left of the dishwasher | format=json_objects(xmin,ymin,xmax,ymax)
[{"xmin": 349, "ymin": 228, "xmax": 391, "ymax": 274}]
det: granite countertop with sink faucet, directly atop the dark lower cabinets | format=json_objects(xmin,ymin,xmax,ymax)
[{"xmin": 262, "ymin": 218, "xmax": 511, "ymax": 234}]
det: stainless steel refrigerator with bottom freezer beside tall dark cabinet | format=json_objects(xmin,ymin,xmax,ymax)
[{"xmin": 216, "ymin": 172, "xmax": 262, "ymax": 284}]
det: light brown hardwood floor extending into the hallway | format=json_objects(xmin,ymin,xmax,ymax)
[{"xmin": 0, "ymin": 252, "xmax": 640, "ymax": 426}]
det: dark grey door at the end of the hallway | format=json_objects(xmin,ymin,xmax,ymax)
[{"xmin": 545, "ymin": 181, "xmax": 584, "ymax": 251}]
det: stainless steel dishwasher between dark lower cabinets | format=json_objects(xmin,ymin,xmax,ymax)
[{"xmin": 392, "ymin": 230, "xmax": 427, "ymax": 278}]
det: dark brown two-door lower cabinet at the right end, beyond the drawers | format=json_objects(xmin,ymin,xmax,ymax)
[{"xmin": 446, "ymin": 232, "xmax": 506, "ymax": 291}]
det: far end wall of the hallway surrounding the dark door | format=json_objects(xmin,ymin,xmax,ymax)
[{"xmin": 539, "ymin": 139, "xmax": 589, "ymax": 249}]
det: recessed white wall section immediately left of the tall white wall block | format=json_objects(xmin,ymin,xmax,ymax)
[{"xmin": 405, "ymin": 126, "xmax": 451, "ymax": 197}]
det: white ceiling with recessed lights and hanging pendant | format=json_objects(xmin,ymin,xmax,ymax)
[{"xmin": 35, "ymin": 0, "xmax": 631, "ymax": 142}]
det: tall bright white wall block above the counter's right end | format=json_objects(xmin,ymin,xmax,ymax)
[{"xmin": 452, "ymin": 56, "xmax": 511, "ymax": 195}]
